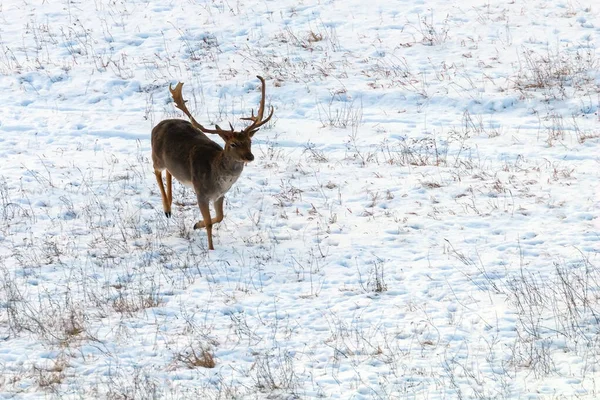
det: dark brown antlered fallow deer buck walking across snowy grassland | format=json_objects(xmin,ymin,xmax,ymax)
[{"xmin": 152, "ymin": 76, "xmax": 274, "ymax": 250}]
